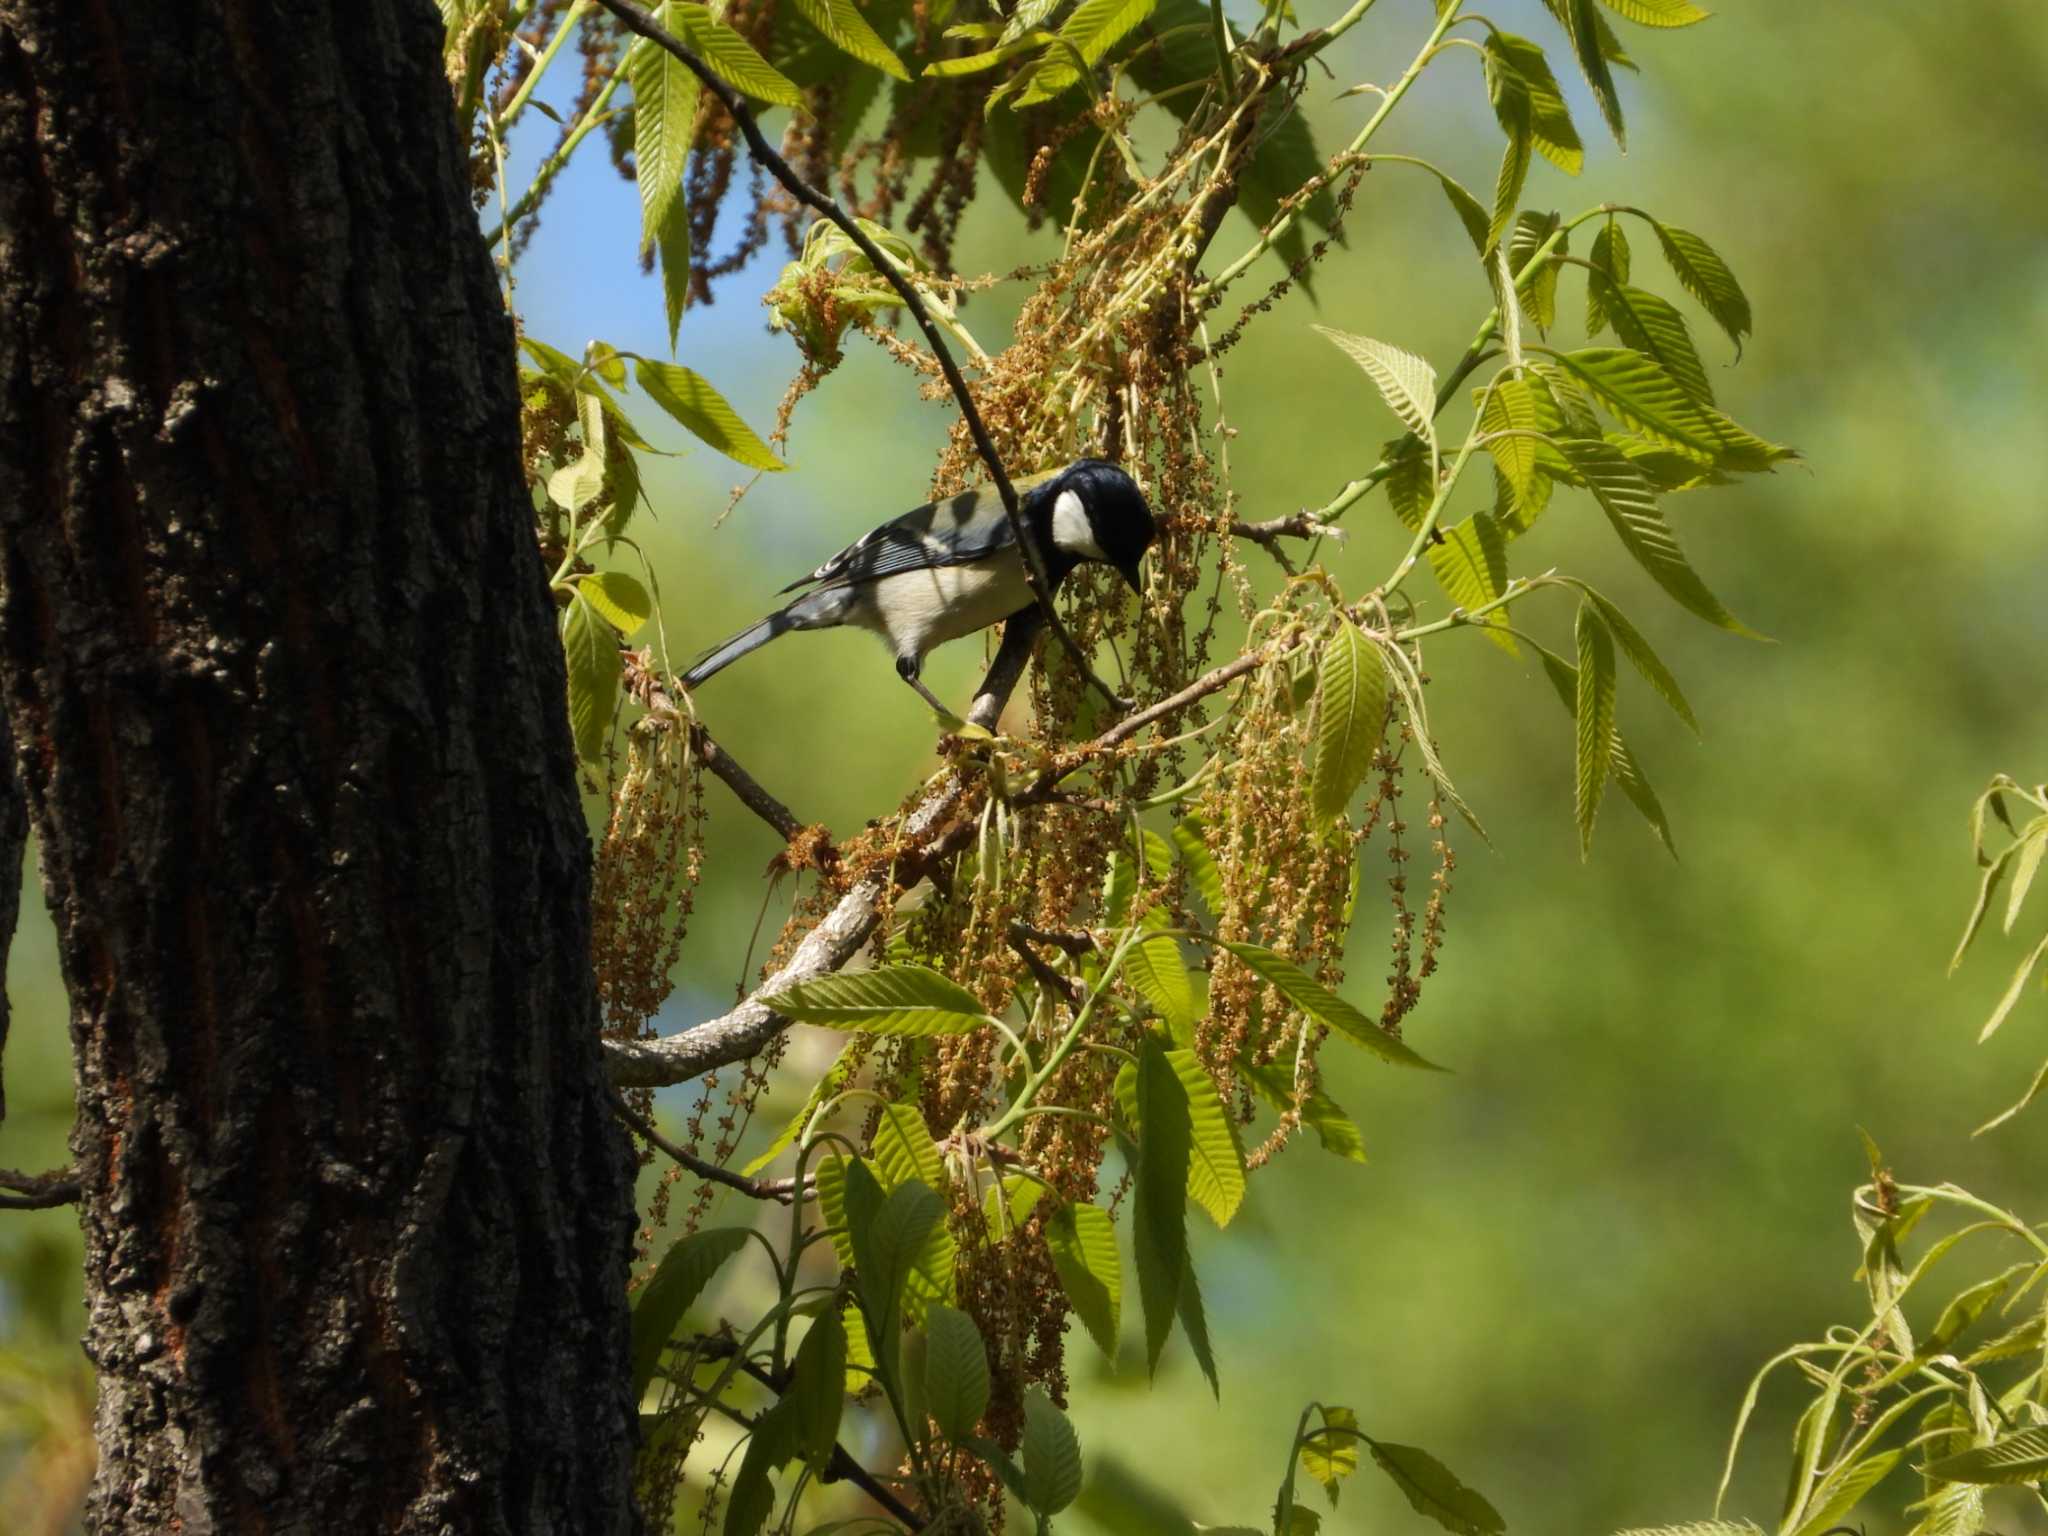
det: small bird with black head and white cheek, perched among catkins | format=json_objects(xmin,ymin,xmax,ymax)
[{"xmin": 682, "ymin": 459, "xmax": 1155, "ymax": 713}]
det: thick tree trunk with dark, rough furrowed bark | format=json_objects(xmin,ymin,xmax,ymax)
[{"xmin": 0, "ymin": 0, "xmax": 635, "ymax": 1532}]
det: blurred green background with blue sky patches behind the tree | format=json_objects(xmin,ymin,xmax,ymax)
[{"xmin": 0, "ymin": 0, "xmax": 2048, "ymax": 1532}]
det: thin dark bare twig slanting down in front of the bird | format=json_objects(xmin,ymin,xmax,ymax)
[{"xmin": 598, "ymin": 0, "xmax": 1130, "ymax": 709}]
